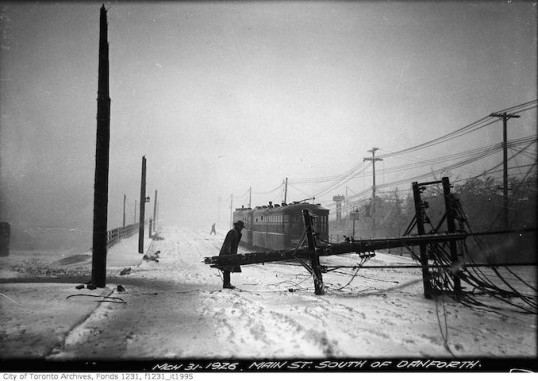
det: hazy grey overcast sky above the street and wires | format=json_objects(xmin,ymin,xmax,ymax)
[{"xmin": 0, "ymin": 1, "xmax": 537, "ymax": 246}]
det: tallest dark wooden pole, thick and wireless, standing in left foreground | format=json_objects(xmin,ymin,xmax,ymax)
[{"xmin": 91, "ymin": 5, "xmax": 110, "ymax": 287}]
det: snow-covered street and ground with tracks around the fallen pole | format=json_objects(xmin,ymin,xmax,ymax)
[{"xmin": 0, "ymin": 227, "xmax": 537, "ymax": 366}]
